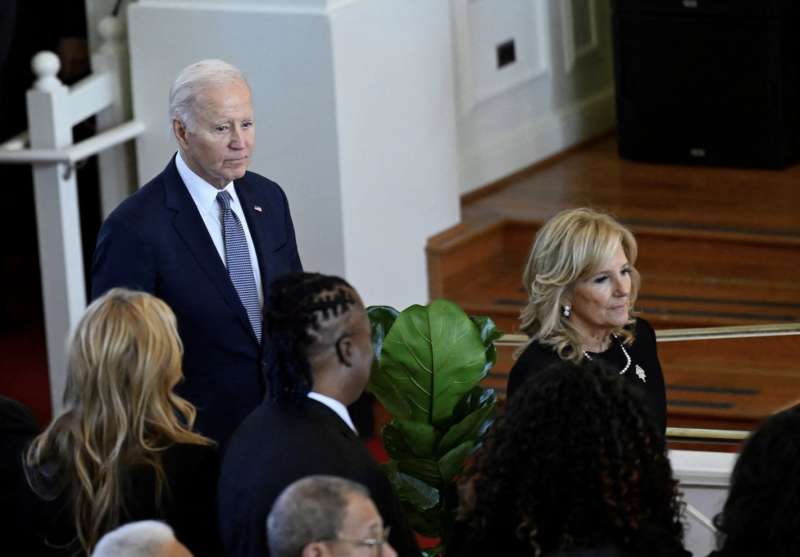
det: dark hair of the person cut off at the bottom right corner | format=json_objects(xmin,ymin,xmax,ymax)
[{"xmin": 714, "ymin": 406, "xmax": 800, "ymax": 557}]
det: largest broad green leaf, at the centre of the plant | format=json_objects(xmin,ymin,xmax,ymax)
[{"xmin": 372, "ymin": 300, "xmax": 487, "ymax": 425}]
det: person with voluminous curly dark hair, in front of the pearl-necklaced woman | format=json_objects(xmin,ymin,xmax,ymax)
[{"xmin": 448, "ymin": 361, "xmax": 688, "ymax": 557}]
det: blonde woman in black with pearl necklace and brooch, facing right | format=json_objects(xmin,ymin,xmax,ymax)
[{"xmin": 506, "ymin": 208, "xmax": 667, "ymax": 432}]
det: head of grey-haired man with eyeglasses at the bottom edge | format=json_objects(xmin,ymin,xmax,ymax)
[{"xmin": 267, "ymin": 476, "xmax": 397, "ymax": 557}]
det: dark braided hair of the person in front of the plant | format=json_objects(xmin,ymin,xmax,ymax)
[{"xmin": 265, "ymin": 273, "xmax": 361, "ymax": 400}]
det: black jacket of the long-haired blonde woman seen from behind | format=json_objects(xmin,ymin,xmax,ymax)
[{"xmin": 10, "ymin": 445, "xmax": 221, "ymax": 557}]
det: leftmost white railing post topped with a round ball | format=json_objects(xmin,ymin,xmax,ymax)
[{"xmin": 27, "ymin": 52, "xmax": 86, "ymax": 415}]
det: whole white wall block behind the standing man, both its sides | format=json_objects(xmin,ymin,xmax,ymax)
[{"xmin": 129, "ymin": 0, "xmax": 459, "ymax": 308}]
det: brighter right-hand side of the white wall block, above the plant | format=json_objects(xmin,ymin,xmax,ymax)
[{"xmin": 331, "ymin": 0, "xmax": 460, "ymax": 308}]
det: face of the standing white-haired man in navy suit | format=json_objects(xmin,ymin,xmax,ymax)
[{"xmin": 172, "ymin": 81, "xmax": 256, "ymax": 189}]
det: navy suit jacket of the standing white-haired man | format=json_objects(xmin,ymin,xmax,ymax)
[{"xmin": 92, "ymin": 157, "xmax": 302, "ymax": 443}]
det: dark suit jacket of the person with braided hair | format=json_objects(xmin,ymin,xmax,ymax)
[{"xmin": 219, "ymin": 399, "xmax": 419, "ymax": 557}]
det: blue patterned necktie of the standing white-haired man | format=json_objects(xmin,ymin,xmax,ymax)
[{"xmin": 217, "ymin": 191, "xmax": 261, "ymax": 342}]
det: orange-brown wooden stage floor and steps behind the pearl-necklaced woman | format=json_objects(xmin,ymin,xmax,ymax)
[{"xmin": 428, "ymin": 136, "xmax": 800, "ymax": 438}]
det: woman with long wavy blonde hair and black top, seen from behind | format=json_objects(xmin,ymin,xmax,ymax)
[{"xmin": 17, "ymin": 288, "xmax": 219, "ymax": 557}]
